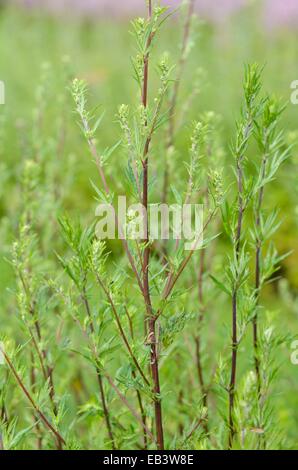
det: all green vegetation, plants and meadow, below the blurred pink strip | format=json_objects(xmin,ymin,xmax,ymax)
[{"xmin": 0, "ymin": 0, "xmax": 298, "ymax": 450}]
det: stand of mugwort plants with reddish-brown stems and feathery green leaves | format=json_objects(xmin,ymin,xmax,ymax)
[{"xmin": 0, "ymin": 0, "xmax": 296, "ymax": 450}]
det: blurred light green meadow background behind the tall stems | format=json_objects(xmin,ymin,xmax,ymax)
[{"xmin": 0, "ymin": 0, "xmax": 298, "ymax": 448}]
